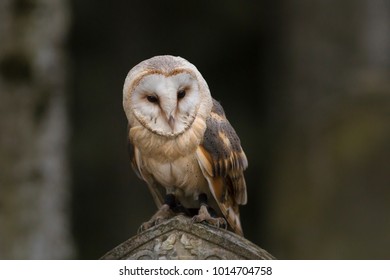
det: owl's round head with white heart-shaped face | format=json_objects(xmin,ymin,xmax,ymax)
[{"xmin": 123, "ymin": 55, "xmax": 212, "ymax": 137}]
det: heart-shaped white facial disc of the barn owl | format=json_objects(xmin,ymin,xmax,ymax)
[{"xmin": 131, "ymin": 71, "xmax": 200, "ymax": 137}]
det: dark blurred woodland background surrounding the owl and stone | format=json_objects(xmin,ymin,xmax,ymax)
[{"xmin": 0, "ymin": 0, "xmax": 390, "ymax": 259}]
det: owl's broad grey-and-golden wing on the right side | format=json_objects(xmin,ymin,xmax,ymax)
[{"xmin": 196, "ymin": 99, "xmax": 248, "ymax": 235}]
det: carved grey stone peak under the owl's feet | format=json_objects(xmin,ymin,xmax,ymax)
[{"xmin": 101, "ymin": 216, "xmax": 274, "ymax": 260}]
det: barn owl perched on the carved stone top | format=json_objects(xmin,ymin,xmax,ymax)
[{"xmin": 123, "ymin": 55, "xmax": 248, "ymax": 235}]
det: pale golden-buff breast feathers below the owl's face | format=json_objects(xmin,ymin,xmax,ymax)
[{"xmin": 129, "ymin": 110, "xmax": 208, "ymax": 203}]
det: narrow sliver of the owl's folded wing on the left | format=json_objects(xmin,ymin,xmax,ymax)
[{"xmin": 127, "ymin": 125, "xmax": 164, "ymax": 208}]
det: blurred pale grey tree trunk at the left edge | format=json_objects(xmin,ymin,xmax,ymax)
[{"xmin": 0, "ymin": 0, "xmax": 73, "ymax": 259}]
